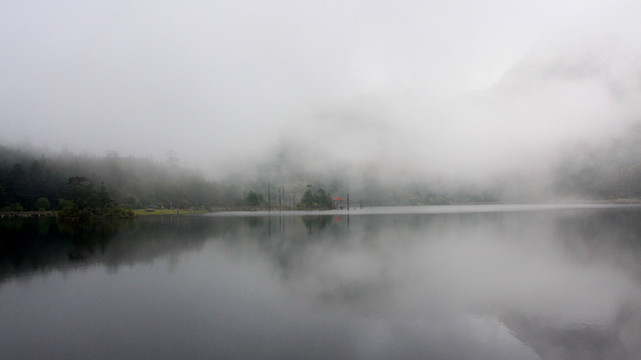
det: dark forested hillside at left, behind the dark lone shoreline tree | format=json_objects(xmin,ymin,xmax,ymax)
[{"xmin": 0, "ymin": 146, "xmax": 242, "ymax": 210}]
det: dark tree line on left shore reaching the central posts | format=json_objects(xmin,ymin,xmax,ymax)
[{"xmin": 0, "ymin": 145, "xmax": 344, "ymax": 215}]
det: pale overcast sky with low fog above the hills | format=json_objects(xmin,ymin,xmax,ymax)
[{"xmin": 0, "ymin": 0, "xmax": 641, "ymax": 179}]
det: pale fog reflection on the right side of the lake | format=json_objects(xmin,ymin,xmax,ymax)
[{"xmin": 272, "ymin": 212, "xmax": 641, "ymax": 359}]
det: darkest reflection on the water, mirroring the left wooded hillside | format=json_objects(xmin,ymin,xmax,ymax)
[{"xmin": 0, "ymin": 217, "xmax": 218, "ymax": 280}]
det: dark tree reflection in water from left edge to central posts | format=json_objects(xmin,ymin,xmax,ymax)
[{"xmin": 0, "ymin": 215, "xmax": 346, "ymax": 281}]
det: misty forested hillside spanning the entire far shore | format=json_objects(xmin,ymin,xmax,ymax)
[{"xmin": 0, "ymin": 127, "xmax": 641, "ymax": 211}]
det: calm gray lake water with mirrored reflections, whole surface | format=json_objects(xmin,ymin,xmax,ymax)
[{"xmin": 0, "ymin": 205, "xmax": 641, "ymax": 359}]
